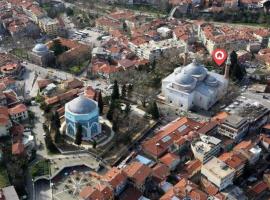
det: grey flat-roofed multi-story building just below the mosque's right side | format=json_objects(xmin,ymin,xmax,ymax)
[{"xmin": 218, "ymin": 115, "xmax": 249, "ymax": 141}]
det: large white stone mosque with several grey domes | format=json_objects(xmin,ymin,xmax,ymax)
[{"xmin": 162, "ymin": 60, "xmax": 228, "ymax": 110}]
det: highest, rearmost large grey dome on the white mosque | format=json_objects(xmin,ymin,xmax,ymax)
[{"xmin": 184, "ymin": 61, "xmax": 207, "ymax": 80}]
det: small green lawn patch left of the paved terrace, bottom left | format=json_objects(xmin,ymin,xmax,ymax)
[{"xmin": 30, "ymin": 160, "xmax": 50, "ymax": 178}]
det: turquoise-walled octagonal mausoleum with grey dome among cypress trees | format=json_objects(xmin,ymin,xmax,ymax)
[{"xmin": 65, "ymin": 95, "xmax": 101, "ymax": 140}]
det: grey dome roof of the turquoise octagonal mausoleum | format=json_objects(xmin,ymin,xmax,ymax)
[{"xmin": 68, "ymin": 95, "xmax": 97, "ymax": 114}]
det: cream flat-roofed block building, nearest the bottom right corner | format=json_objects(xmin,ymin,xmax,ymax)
[{"xmin": 201, "ymin": 157, "xmax": 235, "ymax": 190}]
